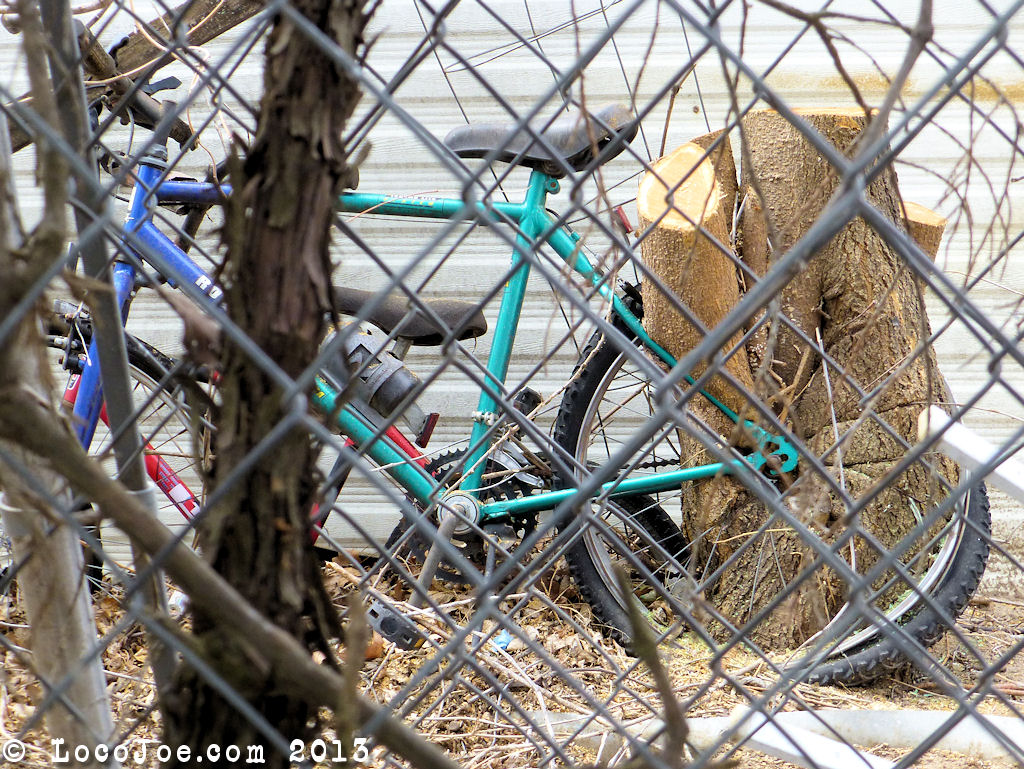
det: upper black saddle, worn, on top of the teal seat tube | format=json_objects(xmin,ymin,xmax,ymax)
[{"xmin": 444, "ymin": 104, "xmax": 637, "ymax": 177}]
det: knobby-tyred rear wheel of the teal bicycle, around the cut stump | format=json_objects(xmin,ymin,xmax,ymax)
[{"xmin": 555, "ymin": 309, "xmax": 990, "ymax": 683}]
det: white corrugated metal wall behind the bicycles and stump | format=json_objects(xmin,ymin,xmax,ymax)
[{"xmin": 0, "ymin": 0, "xmax": 1024, "ymax": 565}]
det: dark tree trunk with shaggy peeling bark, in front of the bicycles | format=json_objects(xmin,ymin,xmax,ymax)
[{"xmin": 166, "ymin": 0, "xmax": 366, "ymax": 767}]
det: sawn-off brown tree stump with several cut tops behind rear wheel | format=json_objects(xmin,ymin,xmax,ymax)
[{"xmin": 641, "ymin": 110, "xmax": 956, "ymax": 648}]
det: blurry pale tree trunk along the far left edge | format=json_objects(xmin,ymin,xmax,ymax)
[{"xmin": 0, "ymin": 36, "xmax": 114, "ymax": 767}]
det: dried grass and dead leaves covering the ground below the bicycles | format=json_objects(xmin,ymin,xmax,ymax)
[{"xmin": 0, "ymin": 565, "xmax": 1024, "ymax": 769}]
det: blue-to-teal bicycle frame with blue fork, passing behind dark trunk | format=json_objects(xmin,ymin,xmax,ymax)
[{"xmin": 81, "ymin": 154, "xmax": 797, "ymax": 524}]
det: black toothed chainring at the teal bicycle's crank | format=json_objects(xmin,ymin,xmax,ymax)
[{"xmin": 386, "ymin": 448, "xmax": 537, "ymax": 585}]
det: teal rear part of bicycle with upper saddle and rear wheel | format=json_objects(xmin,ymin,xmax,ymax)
[{"xmin": 316, "ymin": 106, "xmax": 989, "ymax": 681}]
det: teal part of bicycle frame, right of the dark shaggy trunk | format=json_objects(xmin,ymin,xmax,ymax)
[{"xmin": 313, "ymin": 170, "xmax": 797, "ymax": 524}]
